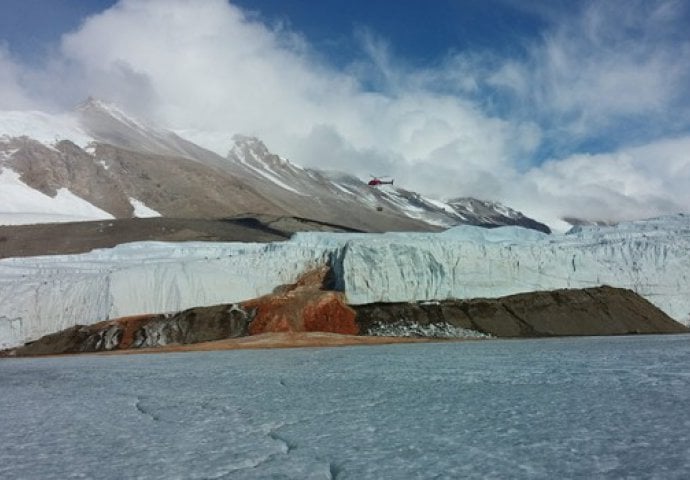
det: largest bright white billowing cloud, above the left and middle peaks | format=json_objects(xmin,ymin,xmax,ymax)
[{"xmin": 53, "ymin": 0, "xmax": 528, "ymax": 194}]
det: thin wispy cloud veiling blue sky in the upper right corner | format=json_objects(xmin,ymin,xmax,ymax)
[{"xmin": 500, "ymin": 1, "xmax": 690, "ymax": 137}]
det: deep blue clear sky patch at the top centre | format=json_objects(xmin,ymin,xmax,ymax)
[{"xmin": 235, "ymin": 0, "xmax": 545, "ymax": 66}]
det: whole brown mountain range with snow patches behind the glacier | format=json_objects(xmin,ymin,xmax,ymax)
[{"xmin": 0, "ymin": 98, "xmax": 548, "ymax": 231}]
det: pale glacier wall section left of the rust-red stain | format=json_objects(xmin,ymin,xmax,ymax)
[{"xmin": 0, "ymin": 242, "xmax": 334, "ymax": 348}]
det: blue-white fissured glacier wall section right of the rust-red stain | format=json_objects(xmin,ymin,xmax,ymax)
[{"xmin": 338, "ymin": 215, "xmax": 690, "ymax": 324}]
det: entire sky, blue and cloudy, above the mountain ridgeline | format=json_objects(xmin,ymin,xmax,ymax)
[{"xmin": 0, "ymin": 0, "xmax": 690, "ymax": 226}]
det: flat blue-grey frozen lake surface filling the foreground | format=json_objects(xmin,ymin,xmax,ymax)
[{"xmin": 0, "ymin": 335, "xmax": 690, "ymax": 480}]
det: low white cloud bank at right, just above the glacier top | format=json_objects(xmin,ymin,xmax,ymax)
[{"xmin": 506, "ymin": 136, "xmax": 690, "ymax": 232}]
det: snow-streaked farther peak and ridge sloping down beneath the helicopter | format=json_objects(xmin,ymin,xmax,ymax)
[{"xmin": 228, "ymin": 135, "xmax": 549, "ymax": 233}]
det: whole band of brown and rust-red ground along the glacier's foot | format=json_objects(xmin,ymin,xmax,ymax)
[{"xmin": 4, "ymin": 284, "xmax": 689, "ymax": 356}]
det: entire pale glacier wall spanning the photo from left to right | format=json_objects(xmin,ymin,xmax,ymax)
[{"xmin": 0, "ymin": 214, "xmax": 690, "ymax": 348}]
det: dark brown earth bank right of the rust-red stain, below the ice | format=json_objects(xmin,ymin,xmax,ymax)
[{"xmin": 353, "ymin": 286, "xmax": 688, "ymax": 337}]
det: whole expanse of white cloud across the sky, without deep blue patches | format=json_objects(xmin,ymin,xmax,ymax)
[{"xmin": 0, "ymin": 0, "xmax": 690, "ymax": 229}]
